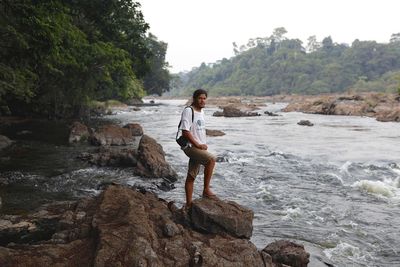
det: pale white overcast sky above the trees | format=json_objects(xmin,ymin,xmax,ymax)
[{"xmin": 137, "ymin": 0, "xmax": 400, "ymax": 73}]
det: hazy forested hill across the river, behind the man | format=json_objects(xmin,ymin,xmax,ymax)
[{"xmin": 171, "ymin": 27, "xmax": 400, "ymax": 96}]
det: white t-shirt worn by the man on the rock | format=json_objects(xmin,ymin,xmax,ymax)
[{"xmin": 179, "ymin": 108, "xmax": 207, "ymax": 144}]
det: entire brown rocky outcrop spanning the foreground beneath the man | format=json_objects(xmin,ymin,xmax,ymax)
[{"xmin": 0, "ymin": 185, "xmax": 308, "ymax": 267}]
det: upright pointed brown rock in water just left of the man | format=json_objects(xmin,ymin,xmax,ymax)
[{"xmin": 137, "ymin": 135, "xmax": 178, "ymax": 182}]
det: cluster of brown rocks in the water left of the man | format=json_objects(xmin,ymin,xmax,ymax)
[{"xmin": 78, "ymin": 123, "xmax": 178, "ymax": 182}]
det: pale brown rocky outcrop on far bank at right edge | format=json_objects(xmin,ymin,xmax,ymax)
[{"xmin": 283, "ymin": 93, "xmax": 400, "ymax": 121}]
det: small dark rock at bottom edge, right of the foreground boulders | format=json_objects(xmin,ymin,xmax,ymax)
[{"xmin": 262, "ymin": 240, "xmax": 310, "ymax": 267}]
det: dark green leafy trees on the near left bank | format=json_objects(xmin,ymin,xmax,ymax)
[{"xmin": 0, "ymin": 0, "xmax": 170, "ymax": 118}]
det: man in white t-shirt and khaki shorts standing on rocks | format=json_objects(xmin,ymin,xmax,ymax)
[{"xmin": 179, "ymin": 89, "xmax": 216, "ymax": 208}]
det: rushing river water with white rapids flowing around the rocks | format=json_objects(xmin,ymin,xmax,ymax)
[{"xmin": 0, "ymin": 100, "xmax": 400, "ymax": 267}]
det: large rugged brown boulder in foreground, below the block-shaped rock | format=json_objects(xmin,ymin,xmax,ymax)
[{"xmin": 95, "ymin": 186, "xmax": 263, "ymax": 266}]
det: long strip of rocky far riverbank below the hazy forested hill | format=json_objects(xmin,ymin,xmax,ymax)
[{"xmin": 152, "ymin": 93, "xmax": 400, "ymax": 122}]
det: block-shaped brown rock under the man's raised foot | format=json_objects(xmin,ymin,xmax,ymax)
[{"xmin": 191, "ymin": 198, "xmax": 254, "ymax": 239}]
